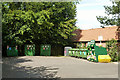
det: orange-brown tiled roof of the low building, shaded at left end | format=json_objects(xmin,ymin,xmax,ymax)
[{"xmin": 72, "ymin": 26, "xmax": 118, "ymax": 42}]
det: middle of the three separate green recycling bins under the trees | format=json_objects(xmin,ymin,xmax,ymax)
[{"xmin": 25, "ymin": 44, "xmax": 35, "ymax": 56}]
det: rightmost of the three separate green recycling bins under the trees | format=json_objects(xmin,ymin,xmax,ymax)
[{"xmin": 40, "ymin": 44, "xmax": 51, "ymax": 56}]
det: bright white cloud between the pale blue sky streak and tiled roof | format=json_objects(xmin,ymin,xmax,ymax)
[{"xmin": 76, "ymin": 10, "xmax": 105, "ymax": 29}]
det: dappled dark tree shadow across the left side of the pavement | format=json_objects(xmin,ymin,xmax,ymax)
[{"xmin": 2, "ymin": 57, "xmax": 60, "ymax": 79}]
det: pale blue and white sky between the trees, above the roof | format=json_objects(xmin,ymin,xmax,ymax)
[{"xmin": 76, "ymin": 0, "xmax": 112, "ymax": 30}]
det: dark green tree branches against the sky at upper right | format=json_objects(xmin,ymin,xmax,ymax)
[{"xmin": 97, "ymin": 1, "xmax": 120, "ymax": 26}]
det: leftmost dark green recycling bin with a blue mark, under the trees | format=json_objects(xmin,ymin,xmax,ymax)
[{"xmin": 7, "ymin": 46, "xmax": 18, "ymax": 56}]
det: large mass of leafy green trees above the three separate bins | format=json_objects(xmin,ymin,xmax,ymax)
[{"xmin": 2, "ymin": 2, "xmax": 76, "ymax": 45}]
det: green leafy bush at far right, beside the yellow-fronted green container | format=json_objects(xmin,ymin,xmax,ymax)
[{"xmin": 106, "ymin": 39, "xmax": 118, "ymax": 61}]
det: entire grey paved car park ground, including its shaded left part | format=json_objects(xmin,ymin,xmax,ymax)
[{"xmin": 2, "ymin": 56, "xmax": 118, "ymax": 78}]
